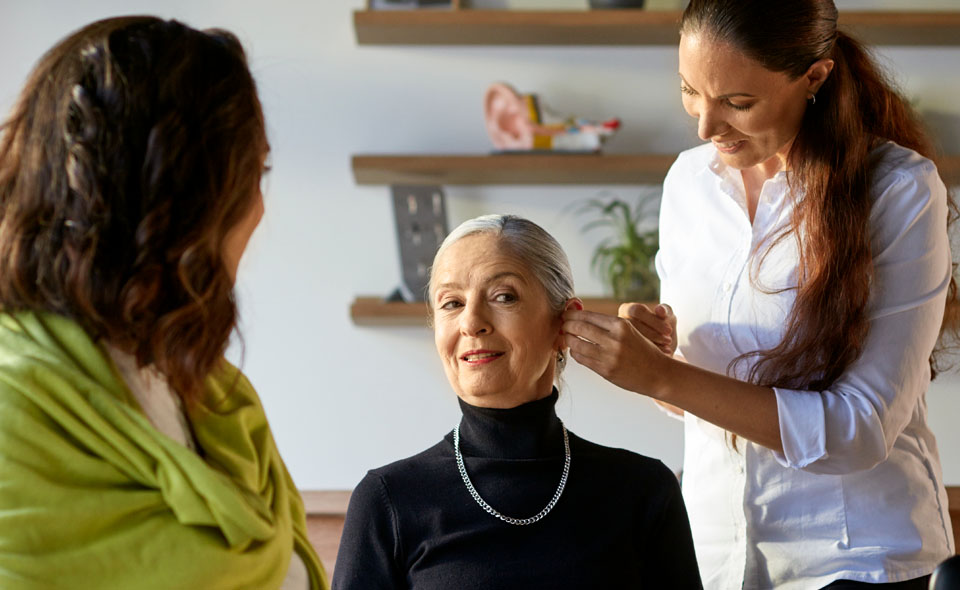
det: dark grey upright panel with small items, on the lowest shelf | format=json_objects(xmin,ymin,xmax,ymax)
[{"xmin": 388, "ymin": 186, "xmax": 448, "ymax": 301}]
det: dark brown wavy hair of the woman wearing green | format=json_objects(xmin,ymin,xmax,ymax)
[{"xmin": 0, "ymin": 16, "xmax": 269, "ymax": 400}]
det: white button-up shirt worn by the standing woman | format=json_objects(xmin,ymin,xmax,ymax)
[{"xmin": 657, "ymin": 143, "xmax": 954, "ymax": 590}]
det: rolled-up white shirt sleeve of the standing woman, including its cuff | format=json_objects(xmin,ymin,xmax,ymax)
[{"xmin": 775, "ymin": 157, "xmax": 952, "ymax": 474}]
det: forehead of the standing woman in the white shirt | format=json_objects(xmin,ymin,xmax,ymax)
[{"xmin": 679, "ymin": 33, "xmax": 790, "ymax": 96}]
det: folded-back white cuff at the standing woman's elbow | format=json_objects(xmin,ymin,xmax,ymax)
[{"xmin": 773, "ymin": 387, "xmax": 827, "ymax": 469}]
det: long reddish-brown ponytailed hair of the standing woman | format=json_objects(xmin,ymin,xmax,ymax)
[{"xmin": 681, "ymin": 0, "xmax": 957, "ymax": 390}]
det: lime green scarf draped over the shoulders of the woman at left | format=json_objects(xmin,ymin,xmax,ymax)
[{"xmin": 0, "ymin": 313, "xmax": 327, "ymax": 590}]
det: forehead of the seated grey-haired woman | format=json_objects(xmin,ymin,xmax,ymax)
[{"xmin": 432, "ymin": 233, "xmax": 535, "ymax": 285}]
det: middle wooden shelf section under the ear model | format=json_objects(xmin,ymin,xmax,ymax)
[{"xmin": 353, "ymin": 154, "xmax": 677, "ymax": 185}]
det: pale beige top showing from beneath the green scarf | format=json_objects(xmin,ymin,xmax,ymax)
[{"xmin": 105, "ymin": 344, "xmax": 310, "ymax": 590}]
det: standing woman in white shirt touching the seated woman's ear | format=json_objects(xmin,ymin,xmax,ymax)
[{"xmin": 563, "ymin": 0, "xmax": 956, "ymax": 590}]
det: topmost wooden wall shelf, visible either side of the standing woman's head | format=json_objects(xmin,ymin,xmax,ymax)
[{"xmin": 353, "ymin": 10, "xmax": 960, "ymax": 46}]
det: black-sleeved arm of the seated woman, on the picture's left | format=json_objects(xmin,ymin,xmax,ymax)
[{"xmin": 332, "ymin": 472, "xmax": 407, "ymax": 590}]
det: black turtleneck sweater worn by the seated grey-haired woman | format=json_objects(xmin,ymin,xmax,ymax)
[{"xmin": 333, "ymin": 391, "xmax": 701, "ymax": 590}]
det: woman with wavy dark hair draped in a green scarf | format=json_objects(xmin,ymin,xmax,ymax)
[{"xmin": 0, "ymin": 17, "xmax": 326, "ymax": 590}]
